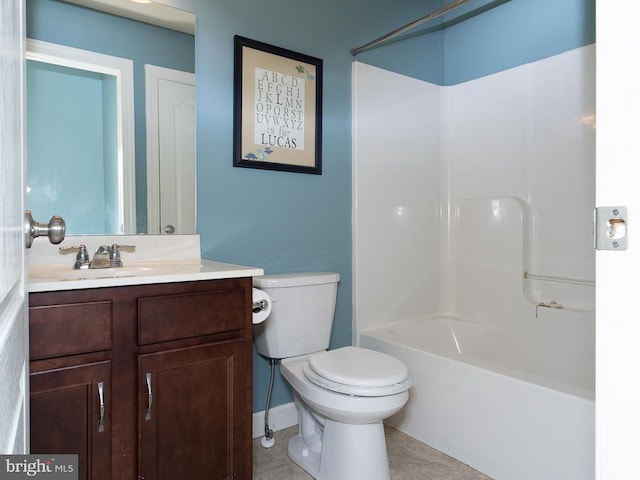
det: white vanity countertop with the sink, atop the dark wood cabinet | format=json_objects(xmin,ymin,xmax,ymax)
[{"xmin": 29, "ymin": 259, "xmax": 264, "ymax": 292}]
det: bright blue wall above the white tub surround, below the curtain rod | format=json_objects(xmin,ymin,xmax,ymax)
[{"xmin": 344, "ymin": 0, "xmax": 595, "ymax": 85}]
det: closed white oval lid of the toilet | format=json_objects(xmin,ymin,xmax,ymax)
[{"xmin": 309, "ymin": 347, "xmax": 409, "ymax": 388}]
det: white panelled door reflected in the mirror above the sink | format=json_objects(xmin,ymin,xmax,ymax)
[{"xmin": 145, "ymin": 65, "xmax": 196, "ymax": 234}]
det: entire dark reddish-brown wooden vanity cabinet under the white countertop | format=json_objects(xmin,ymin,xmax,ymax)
[{"xmin": 29, "ymin": 278, "xmax": 252, "ymax": 480}]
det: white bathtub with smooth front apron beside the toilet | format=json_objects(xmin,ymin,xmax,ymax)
[{"xmin": 359, "ymin": 312, "xmax": 595, "ymax": 480}]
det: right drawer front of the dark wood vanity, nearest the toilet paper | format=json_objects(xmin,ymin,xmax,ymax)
[{"xmin": 138, "ymin": 288, "xmax": 250, "ymax": 345}]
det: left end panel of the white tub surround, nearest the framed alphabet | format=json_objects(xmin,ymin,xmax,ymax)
[{"xmin": 353, "ymin": 63, "xmax": 444, "ymax": 338}]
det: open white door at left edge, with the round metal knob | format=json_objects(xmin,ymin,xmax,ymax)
[{"xmin": 0, "ymin": 0, "xmax": 29, "ymax": 454}]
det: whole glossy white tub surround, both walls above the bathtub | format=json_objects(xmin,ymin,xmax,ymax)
[{"xmin": 353, "ymin": 46, "xmax": 595, "ymax": 335}]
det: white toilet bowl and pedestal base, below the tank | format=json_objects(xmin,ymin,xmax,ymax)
[{"xmin": 280, "ymin": 347, "xmax": 411, "ymax": 480}]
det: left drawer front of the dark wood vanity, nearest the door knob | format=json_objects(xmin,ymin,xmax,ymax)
[{"xmin": 29, "ymin": 300, "xmax": 113, "ymax": 360}]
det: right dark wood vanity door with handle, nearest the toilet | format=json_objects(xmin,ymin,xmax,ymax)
[{"xmin": 138, "ymin": 340, "xmax": 251, "ymax": 480}]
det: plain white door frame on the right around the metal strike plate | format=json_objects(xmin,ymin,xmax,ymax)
[{"xmin": 596, "ymin": 0, "xmax": 640, "ymax": 480}]
